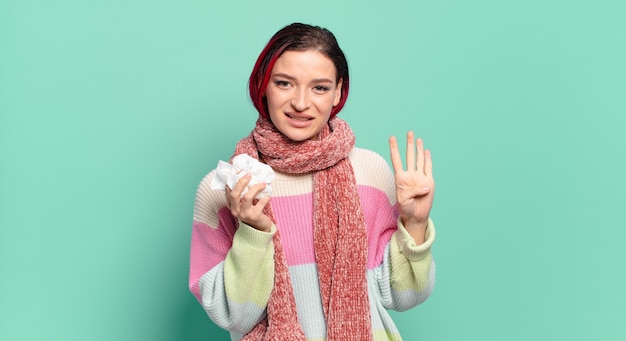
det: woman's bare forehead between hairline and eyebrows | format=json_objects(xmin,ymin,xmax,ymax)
[{"xmin": 272, "ymin": 50, "xmax": 337, "ymax": 79}]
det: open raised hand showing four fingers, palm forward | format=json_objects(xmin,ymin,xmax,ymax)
[{"xmin": 389, "ymin": 131, "xmax": 435, "ymax": 243}]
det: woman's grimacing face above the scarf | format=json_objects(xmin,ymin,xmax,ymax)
[{"xmin": 265, "ymin": 50, "xmax": 342, "ymax": 141}]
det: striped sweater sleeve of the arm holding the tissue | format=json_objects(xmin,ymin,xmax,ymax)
[{"xmin": 189, "ymin": 172, "xmax": 276, "ymax": 334}]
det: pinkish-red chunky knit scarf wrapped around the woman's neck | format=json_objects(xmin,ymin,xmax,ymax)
[{"xmin": 233, "ymin": 116, "xmax": 372, "ymax": 341}]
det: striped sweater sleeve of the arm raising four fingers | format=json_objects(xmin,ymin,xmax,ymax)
[{"xmin": 353, "ymin": 149, "xmax": 435, "ymax": 311}]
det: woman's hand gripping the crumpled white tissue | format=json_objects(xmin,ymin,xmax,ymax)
[{"xmin": 226, "ymin": 174, "xmax": 273, "ymax": 232}]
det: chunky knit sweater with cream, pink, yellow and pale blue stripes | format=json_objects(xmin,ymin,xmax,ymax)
[{"xmin": 189, "ymin": 148, "xmax": 435, "ymax": 341}]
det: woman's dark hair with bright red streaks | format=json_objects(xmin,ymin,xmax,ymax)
[{"xmin": 248, "ymin": 23, "xmax": 350, "ymax": 119}]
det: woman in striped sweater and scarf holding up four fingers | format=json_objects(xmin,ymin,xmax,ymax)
[{"xmin": 190, "ymin": 24, "xmax": 435, "ymax": 341}]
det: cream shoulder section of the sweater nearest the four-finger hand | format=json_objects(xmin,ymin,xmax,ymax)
[{"xmin": 349, "ymin": 148, "xmax": 395, "ymax": 200}]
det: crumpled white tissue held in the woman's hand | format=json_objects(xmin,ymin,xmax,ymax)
[{"xmin": 211, "ymin": 154, "xmax": 276, "ymax": 199}]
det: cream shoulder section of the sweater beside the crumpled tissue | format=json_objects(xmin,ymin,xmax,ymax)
[{"xmin": 193, "ymin": 170, "xmax": 226, "ymax": 227}]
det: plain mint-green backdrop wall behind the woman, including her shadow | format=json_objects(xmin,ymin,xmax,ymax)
[{"xmin": 0, "ymin": 0, "xmax": 626, "ymax": 340}]
